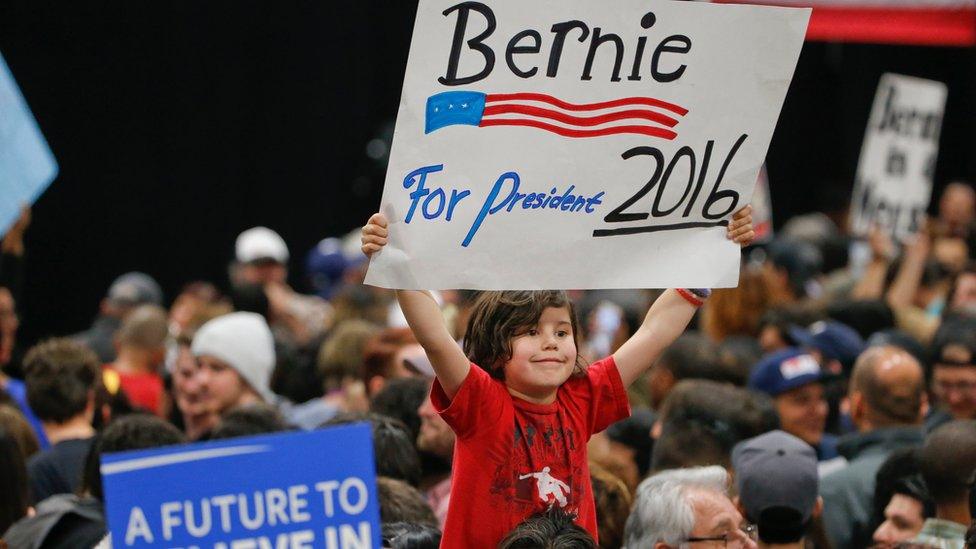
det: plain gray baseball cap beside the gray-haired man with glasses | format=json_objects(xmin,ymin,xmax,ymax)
[{"xmin": 732, "ymin": 431, "xmax": 819, "ymax": 523}]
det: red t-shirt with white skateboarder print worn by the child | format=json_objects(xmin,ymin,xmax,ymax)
[{"xmin": 430, "ymin": 357, "xmax": 630, "ymax": 548}]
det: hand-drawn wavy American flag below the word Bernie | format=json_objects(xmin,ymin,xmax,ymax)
[{"xmin": 424, "ymin": 91, "xmax": 688, "ymax": 140}]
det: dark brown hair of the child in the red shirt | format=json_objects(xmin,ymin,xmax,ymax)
[{"xmin": 464, "ymin": 290, "xmax": 584, "ymax": 380}]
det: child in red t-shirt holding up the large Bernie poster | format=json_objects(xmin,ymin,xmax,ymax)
[{"xmin": 362, "ymin": 206, "xmax": 754, "ymax": 547}]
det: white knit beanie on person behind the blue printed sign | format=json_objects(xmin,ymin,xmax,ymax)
[{"xmin": 191, "ymin": 313, "xmax": 275, "ymax": 403}]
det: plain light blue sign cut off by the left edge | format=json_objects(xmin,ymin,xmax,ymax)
[{"xmin": 0, "ymin": 55, "xmax": 58, "ymax": 235}]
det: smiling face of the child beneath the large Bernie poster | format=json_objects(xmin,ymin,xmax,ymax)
[{"xmin": 504, "ymin": 307, "xmax": 576, "ymax": 404}]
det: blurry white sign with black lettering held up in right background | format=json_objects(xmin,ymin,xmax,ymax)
[{"xmin": 851, "ymin": 74, "xmax": 947, "ymax": 238}]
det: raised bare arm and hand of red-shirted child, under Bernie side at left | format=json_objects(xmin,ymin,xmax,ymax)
[{"xmin": 362, "ymin": 213, "xmax": 471, "ymax": 399}]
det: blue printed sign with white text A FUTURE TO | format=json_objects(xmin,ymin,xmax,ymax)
[{"xmin": 101, "ymin": 423, "xmax": 380, "ymax": 549}]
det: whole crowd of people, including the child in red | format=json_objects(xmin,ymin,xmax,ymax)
[{"xmin": 0, "ymin": 183, "xmax": 976, "ymax": 549}]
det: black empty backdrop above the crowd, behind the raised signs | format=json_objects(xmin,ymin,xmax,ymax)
[{"xmin": 0, "ymin": 0, "xmax": 976, "ymax": 344}]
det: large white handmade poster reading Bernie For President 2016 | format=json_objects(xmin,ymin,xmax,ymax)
[{"xmin": 366, "ymin": 0, "xmax": 810, "ymax": 289}]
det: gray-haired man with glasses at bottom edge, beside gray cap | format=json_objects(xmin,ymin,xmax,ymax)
[{"xmin": 624, "ymin": 465, "xmax": 756, "ymax": 549}]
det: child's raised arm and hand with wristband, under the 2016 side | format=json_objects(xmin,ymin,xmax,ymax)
[{"xmin": 613, "ymin": 206, "xmax": 755, "ymax": 387}]
